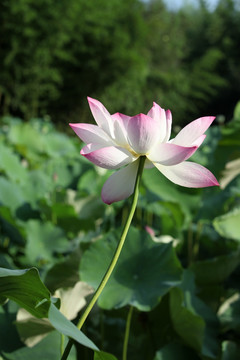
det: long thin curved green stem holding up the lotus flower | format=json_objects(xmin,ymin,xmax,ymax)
[{"xmin": 61, "ymin": 156, "xmax": 145, "ymax": 360}]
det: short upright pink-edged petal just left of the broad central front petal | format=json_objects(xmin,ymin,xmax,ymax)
[{"xmin": 112, "ymin": 113, "xmax": 130, "ymax": 146}]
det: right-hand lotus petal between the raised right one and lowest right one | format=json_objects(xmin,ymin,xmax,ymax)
[{"xmin": 147, "ymin": 143, "xmax": 197, "ymax": 166}]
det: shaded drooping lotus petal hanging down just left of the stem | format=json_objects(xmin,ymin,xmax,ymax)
[{"xmin": 101, "ymin": 160, "xmax": 139, "ymax": 205}]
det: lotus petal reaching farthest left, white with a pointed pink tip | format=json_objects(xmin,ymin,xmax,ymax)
[{"xmin": 69, "ymin": 123, "xmax": 113, "ymax": 146}]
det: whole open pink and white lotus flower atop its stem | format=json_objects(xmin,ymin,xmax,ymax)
[{"xmin": 69, "ymin": 98, "xmax": 219, "ymax": 204}]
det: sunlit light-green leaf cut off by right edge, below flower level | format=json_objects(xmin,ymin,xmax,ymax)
[{"xmin": 213, "ymin": 208, "xmax": 240, "ymax": 241}]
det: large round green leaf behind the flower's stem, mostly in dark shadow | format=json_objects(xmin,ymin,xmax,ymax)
[{"xmin": 80, "ymin": 228, "xmax": 182, "ymax": 311}]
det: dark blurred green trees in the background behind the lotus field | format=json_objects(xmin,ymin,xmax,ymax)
[{"xmin": 0, "ymin": 0, "xmax": 240, "ymax": 124}]
